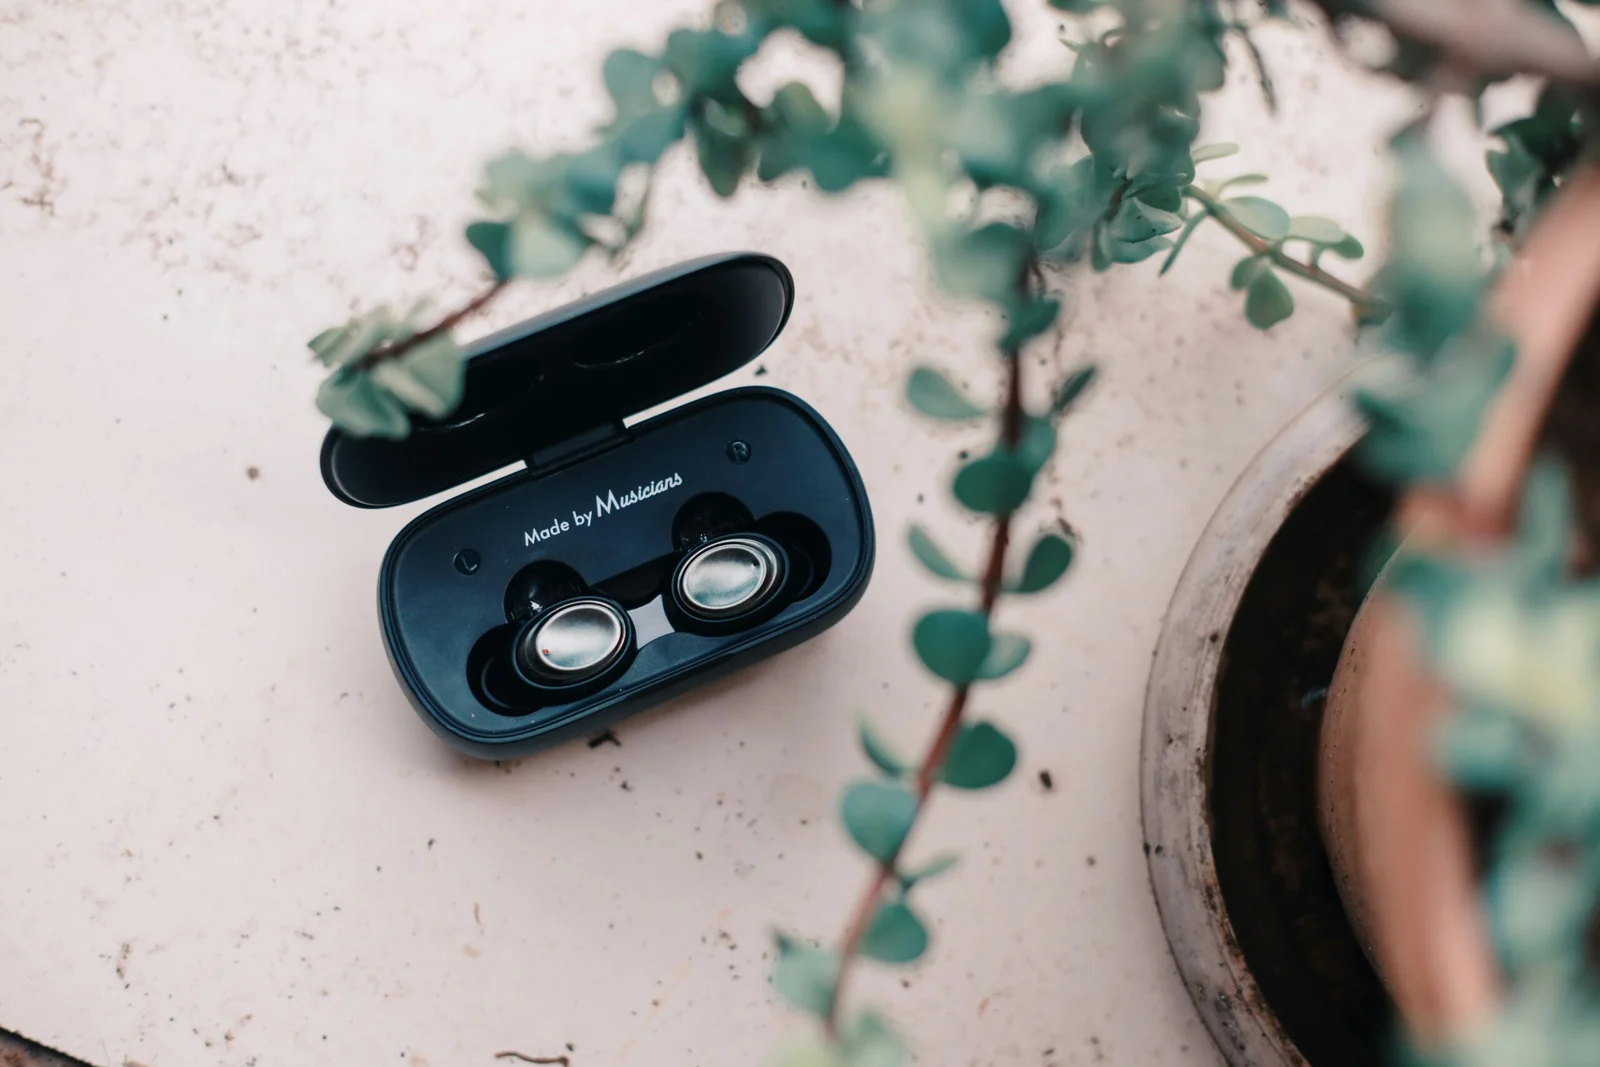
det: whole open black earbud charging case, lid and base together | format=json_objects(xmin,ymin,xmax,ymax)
[{"xmin": 322, "ymin": 254, "xmax": 874, "ymax": 760}]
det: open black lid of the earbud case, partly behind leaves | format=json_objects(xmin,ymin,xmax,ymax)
[{"xmin": 322, "ymin": 253, "xmax": 794, "ymax": 507}]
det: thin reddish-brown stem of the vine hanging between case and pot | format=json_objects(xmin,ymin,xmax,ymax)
[{"xmin": 824, "ymin": 352, "xmax": 1024, "ymax": 1037}]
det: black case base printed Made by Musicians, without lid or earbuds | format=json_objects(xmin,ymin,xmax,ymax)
[{"xmin": 379, "ymin": 389, "xmax": 874, "ymax": 758}]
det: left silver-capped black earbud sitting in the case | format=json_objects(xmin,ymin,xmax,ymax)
[{"xmin": 506, "ymin": 560, "xmax": 635, "ymax": 689}]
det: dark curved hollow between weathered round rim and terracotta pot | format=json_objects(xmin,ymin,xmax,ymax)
[{"xmin": 1210, "ymin": 458, "xmax": 1394, "ymax": 1067}]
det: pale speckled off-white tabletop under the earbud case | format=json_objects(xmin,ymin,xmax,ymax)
[{"xmin": 0, "ymin": 0, "xmax": 1452, "ymax": 1067}]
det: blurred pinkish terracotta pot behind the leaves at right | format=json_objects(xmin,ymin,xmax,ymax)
[{"xmin": 1318, "ymin": 170, "xmax": 1600, "ymax": 1043}]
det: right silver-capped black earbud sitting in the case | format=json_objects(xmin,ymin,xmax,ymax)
[{"xmin": 667, "ymin": 533, "xmax": 789, "ymax": 633}]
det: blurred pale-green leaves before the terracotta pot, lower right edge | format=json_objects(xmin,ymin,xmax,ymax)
[{"xmin": 1390, "ymin": 463, "xmax": 1600, "ymax": 1067}]
